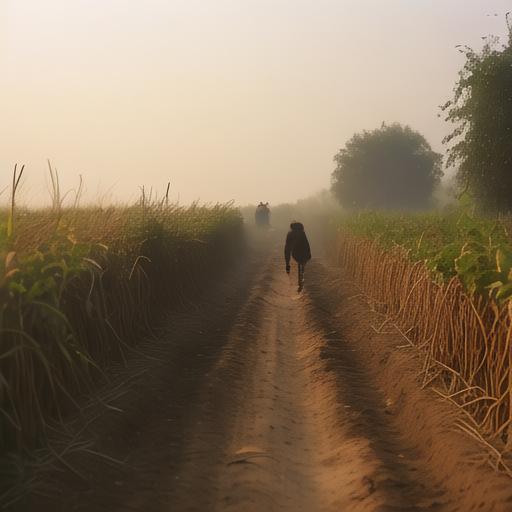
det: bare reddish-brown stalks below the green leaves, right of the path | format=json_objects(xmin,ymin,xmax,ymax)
[{"xmin": 336, "ymin": 235, "xmax": 512, "ymax": 449}]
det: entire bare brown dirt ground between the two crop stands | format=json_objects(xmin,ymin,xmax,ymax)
[{"xmin": 11, "ymin": 233, "xmax": 512, "ymax": 512}]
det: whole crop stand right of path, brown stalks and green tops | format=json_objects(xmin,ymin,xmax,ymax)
[{"xmin": 331, "ymin": 213, "xmax": 512, "ymax": 460}]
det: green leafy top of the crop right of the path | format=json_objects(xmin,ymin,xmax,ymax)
[{"xmin": 341, "ymin": 209, "xmax": 512, "ymax": 301}]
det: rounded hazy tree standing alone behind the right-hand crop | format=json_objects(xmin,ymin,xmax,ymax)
[{"xmin": 332, "ymin": 124, "xmax": 443, "ymax": 209}]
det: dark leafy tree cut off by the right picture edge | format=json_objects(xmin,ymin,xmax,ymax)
[{"xmin": 441, "ymin": 17, "xmax": 512, "ymax": 212}]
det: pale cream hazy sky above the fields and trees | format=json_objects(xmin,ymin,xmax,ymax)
[{"xmin": 0, "ymin": 0, "xmax": 512, "ymax": 203}]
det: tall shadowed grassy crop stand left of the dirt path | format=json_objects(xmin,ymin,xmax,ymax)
[{"xmin": 0, "ymin": 198, "xmax": 242, "ymax": 452}]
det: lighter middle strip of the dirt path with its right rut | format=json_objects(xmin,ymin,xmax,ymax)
[{"xmin": 165, "ymin": 254, "xmax": 439, "ymax": 511}]
